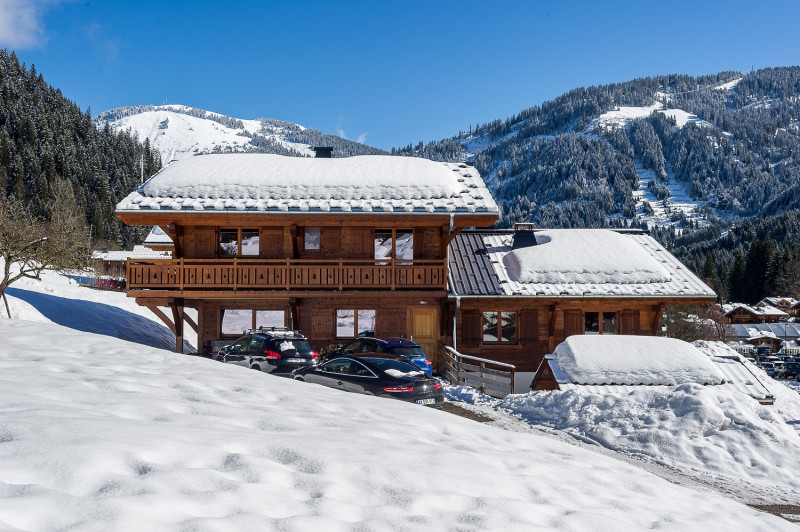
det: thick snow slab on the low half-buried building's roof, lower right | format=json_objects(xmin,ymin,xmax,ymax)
[{"xmin": 553, "ymin": 334, "xmax": 725, "ymax": 386}]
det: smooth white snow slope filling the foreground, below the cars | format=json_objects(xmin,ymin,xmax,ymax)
[{"xmin": 0, "ymin": 320, "xmax": 796, "ymax": 531}]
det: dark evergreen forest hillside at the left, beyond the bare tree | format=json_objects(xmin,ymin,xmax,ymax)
[{"xmin": 0, "ymin": 50, "xmax": 161, "ymax": 247}]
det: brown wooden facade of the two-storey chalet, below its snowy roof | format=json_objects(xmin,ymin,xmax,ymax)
[{"xmin": 119, "ymin": 213, "xmax": 476, "ymax": 356}]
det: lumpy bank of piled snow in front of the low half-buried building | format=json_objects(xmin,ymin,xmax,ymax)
[{"xmin": 448, "ymin": 342, "xmax": 800, "ymax": 504}]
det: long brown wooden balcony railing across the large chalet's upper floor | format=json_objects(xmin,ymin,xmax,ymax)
[{"xmin": 127, "ymin": 258, "xmax": 447, "ymax": 292}]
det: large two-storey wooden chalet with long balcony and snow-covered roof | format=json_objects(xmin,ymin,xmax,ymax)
[{"xmin": 117, "ymin": 154, "xmax": 499, "ymax": 356}]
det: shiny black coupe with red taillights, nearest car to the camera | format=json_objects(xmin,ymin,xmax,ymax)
[{"xmin": 294, "ymin": 353, "xmax": 444, "ymax": 406}]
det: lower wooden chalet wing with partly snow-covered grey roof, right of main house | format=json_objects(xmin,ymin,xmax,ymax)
[{"xmin": 446, "ymin": 224, "xmax": 716, "ymax": 376}]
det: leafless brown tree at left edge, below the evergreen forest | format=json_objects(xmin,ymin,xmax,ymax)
[{"xmin": 0, "ymin": 180, "xmax": 90, "ymax": 318}]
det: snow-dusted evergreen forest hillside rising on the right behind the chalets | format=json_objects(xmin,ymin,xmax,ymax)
[{"xmin": 393, "ymin": 67, "xmax": 800, "ymax": 303}]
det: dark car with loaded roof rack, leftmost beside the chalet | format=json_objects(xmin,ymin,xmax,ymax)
[{"xmin": 215, "ymin": 327, "xmax": 319, "ymax": 376}]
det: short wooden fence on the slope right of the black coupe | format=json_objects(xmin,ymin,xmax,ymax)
[{"xmin": 443, "ymin": 346, "xmax": 515, "ymax": 398}]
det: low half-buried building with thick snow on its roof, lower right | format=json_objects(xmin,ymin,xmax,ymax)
[{"xmin": 531, "ymin": 336, "xmax": 774, "ymax": 404}]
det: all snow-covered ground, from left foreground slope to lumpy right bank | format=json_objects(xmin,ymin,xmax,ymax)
[{"xmin": 0, "ymin": 274, "xmax": 800, "ymax": 531}]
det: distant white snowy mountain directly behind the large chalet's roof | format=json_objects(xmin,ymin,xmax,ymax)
[{"xmin": 94, "ymin": 105, "xmax": 384, "ymax": 163}]
